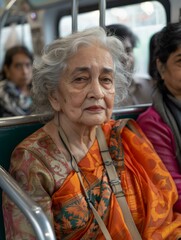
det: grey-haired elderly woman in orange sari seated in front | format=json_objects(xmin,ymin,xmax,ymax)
[{"xmin": 3, "ymin": 28, "xmax": 181, "ymax": 240}]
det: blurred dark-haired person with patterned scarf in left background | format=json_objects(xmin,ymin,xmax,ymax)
[{"xmin": 0, "ymin": 46, "xmax": 33, "ymax": 117}]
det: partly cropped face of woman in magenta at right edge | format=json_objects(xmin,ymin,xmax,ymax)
[{"xmin": 161, "ymin": 46, "xmax": 181, "ymax": 99}]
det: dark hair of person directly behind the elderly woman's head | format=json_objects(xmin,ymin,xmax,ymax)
[{"xmin": 106, "ymin": 24, "xmax": 138, "ymax": 48}]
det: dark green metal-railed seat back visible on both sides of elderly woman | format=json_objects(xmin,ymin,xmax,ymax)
[{"xmin": 0, "ymin": 104, "xmax": 150, "ymax": 240}]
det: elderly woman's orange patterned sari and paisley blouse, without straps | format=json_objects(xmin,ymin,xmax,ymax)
[{"xmin": 3, "ymin": 120, "xmax": 181, "ymax": 240}]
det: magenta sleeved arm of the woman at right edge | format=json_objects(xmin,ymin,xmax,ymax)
[{"xmin": 137, "ymin": 111, "xmax": 181, "ymax": 212}]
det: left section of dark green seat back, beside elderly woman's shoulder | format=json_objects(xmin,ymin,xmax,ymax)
[{"xmin": 0, "ymin": 116, "xmax": 46, "ymax": 240}]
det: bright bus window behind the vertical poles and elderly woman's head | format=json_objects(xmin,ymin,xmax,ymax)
[{"xmin": 59, "ymin": 1, "xmax": 167, "ymax": 78}]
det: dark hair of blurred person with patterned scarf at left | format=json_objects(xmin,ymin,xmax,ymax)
[{"xmin": 2, "ymin": 45, "xmax": 33, "ymax": 79}]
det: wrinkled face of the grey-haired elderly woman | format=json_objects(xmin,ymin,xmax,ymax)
[{"xmin": 52, "ymin": 46, "xmax": 115, "ymax": 126}]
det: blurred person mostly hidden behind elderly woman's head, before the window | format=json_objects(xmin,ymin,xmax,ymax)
[{"xmin": 106, "ymin": 24, "xmax": 153, "ymax": 108}]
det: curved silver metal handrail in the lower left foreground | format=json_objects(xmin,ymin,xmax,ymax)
[{"xmin": 0, "ymin": 166, "xmax": 56, "ymax": 240}]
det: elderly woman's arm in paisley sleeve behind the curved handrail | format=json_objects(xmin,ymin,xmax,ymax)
[{"xmin": 3, "ymin": 149, "xmax": 54, "ymax": 240}]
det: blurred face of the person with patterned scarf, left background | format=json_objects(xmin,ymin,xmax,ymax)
[{"xmin": 5, "ymin": 53, "xmax": 32, "ymax": 89}]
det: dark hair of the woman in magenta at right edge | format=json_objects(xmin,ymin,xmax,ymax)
[{"xmin": 155, "ymin": 22, "xmax": 181, "ymax": 92}]
